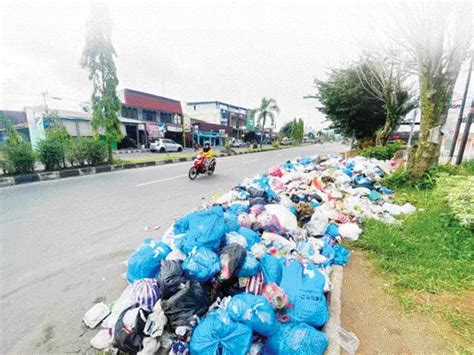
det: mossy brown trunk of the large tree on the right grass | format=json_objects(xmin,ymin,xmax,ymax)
[{"xmin": 408, "ymin": 73, "xmax": 449, "ymax": 176}]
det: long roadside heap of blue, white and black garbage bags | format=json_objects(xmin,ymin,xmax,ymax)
[{"xmin": 84, "ymin": 156, "xmax": 414, "ymax": 355}]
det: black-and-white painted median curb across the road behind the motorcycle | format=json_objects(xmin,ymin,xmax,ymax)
[{"xmin": 0, "ymin": 147, "xmax": 293, "ymax": 188}]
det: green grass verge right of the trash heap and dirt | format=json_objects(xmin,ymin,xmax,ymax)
[{"xmin": 355, "ymin": 186, "xmax": 474, "ymax": 339}]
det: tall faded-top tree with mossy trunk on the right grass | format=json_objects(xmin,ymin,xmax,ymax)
[{"xmin": 393, "ymin": 1, "xmax": 472, "ymax": 176}]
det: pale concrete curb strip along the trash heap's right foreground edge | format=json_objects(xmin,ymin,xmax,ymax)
[{"xmin": 324, "ymin": 265, "xmax": 344, "ymax": 355}]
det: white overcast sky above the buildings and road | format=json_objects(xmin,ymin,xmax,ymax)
[{"xmin": 0, "ymin": 0, "xmax": 412, "ymax": 127}]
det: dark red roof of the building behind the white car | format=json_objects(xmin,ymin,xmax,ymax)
[{"xmin": 123, "ymin": 89, "xmax": 183, "ymax": 115}]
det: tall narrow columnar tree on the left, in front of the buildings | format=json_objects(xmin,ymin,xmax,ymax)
[{"xmin": 81, "ymin": 5, "xmax": 122, "ymax": 163}]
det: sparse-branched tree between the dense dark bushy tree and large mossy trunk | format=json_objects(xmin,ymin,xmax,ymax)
[{"xmin": 358, "ymin": 54, "xmax": 417, "ymax": 145}]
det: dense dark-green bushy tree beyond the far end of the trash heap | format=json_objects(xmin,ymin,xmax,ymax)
[{"xmin": 305, "ymin": 63, "xmax": 385, "ymax": 140}]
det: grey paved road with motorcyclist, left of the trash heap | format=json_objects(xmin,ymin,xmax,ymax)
[{"xmin": 0, "ymin": 143, "xmax": 343, "ymax": 354}]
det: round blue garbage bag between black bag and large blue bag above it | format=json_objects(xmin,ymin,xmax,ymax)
[{"xmin": 182, "ymin": 247, "xmax": 221, "ymax": 282}]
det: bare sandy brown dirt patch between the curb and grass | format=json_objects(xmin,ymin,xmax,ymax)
[{"xmin": 341, "ymin": 250, "xmax": 470, "ymax": 354}]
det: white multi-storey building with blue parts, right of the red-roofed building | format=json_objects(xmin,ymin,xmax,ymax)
[{"xmin": 185, "ymin": 101, "xmax": 249, "ymax": 144}]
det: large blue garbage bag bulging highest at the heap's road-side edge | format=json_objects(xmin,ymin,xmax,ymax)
[{"xmin": 174, "ymin": 206, "xmax": 227, "ymax": 254}]
